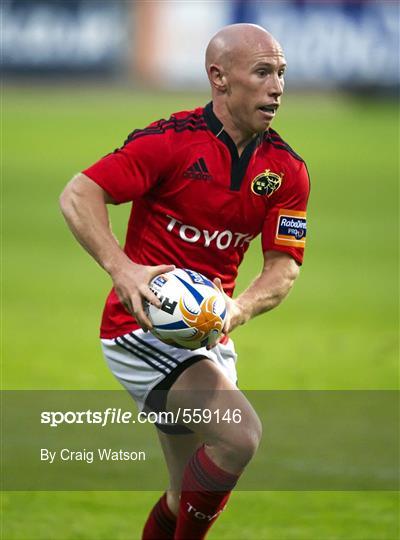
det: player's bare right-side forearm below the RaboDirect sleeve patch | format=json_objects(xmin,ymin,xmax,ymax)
[{"xmin": 216, "ymin": 251, "xmax": 299, "ymax": 333}]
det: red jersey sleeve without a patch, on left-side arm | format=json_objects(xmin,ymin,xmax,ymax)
[{"xmin": 82, "ymin": 122, "xmax": 169, "ymax": 203}]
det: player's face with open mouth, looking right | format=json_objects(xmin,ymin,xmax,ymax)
[{"xmin": 225, "ymin": 43, "xmax": 286, "ymax": 133}]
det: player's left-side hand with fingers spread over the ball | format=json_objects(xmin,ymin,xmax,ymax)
[{"xmin": 111, "ymin": 261, "xmax": 175, "ymax": 332}]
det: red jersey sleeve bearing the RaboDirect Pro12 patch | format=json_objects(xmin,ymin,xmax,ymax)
[{"xmin": 261, "ymin": 161, "xmax": 310, "ymax": 265}]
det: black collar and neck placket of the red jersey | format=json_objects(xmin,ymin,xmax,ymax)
[{"xmin": 203, "ymin": 101, "xmax": 263, "ymax": 191}]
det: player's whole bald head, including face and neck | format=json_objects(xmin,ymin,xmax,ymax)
[{"xmin": 206, "ymin": 24, "xmax": 286, "ymax": 141}]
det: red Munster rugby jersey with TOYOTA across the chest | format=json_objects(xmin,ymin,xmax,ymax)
[{"xmin": 83, "ymin": 103, "xmax": 310, "ymax": 338}]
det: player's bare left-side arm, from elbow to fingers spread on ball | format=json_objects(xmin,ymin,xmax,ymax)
[{"xmin": 60, "ymin": 173, "xmax": 174, "ymax": 329}]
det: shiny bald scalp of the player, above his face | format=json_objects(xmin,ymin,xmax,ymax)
[{"xmin": 206, "ymin": 23, "xmax": 282, "ymax": 74}]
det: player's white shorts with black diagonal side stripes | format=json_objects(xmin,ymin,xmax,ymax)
[{"xmin": 101, "ymin": 329, "xmax": 237, "ymax": 430}]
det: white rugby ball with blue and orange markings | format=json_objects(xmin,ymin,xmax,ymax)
[{"xmin": 145, "ymin": 268, "xmax": 226, "ymax": 350}]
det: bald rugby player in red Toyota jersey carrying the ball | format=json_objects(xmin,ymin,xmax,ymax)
[{"xmin": 61, "ymin": 24, "xmax": 309, "ymax": 540}]
